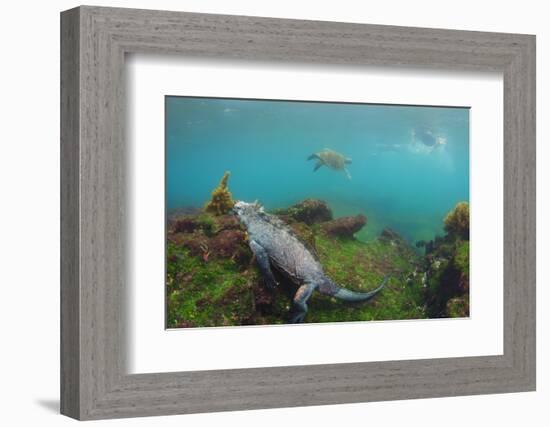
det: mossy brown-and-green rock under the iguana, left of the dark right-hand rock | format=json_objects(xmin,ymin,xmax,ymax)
[{"xmin": 166, "ymin": 199, "xmax": 434, "ymax": 327}]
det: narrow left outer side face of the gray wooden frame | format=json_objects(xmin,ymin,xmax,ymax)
[{"xmin": 60, "ymin": 10, "xmax": 80, "ymax": 417}]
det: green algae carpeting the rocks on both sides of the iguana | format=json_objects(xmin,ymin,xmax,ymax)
[{"xmin": 166, "ymin": 214, "xmax": 427, "ymax": 328}]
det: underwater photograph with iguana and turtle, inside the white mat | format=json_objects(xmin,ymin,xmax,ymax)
[{"xmin": 165, "ymin": 96, "xmax": 470, "ymax": 329}]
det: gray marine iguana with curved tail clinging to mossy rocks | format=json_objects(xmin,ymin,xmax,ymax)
[{"xmin": 233, "ymin": 201, "xmax": 388, "ymax": 323}]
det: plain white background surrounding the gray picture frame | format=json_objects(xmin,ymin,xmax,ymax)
[{"xmin": 0, "ymin": 0, "xmax": 550, "ymax": 427}]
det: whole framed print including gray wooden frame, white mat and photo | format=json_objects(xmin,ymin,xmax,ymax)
[{"xmin": 61, "ymin": 6, "xmax": 535, "ymax": 419}]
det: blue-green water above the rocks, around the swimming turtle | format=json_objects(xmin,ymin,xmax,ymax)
[{"xmin": 166, "ymin": 97, "xmax": 469, "ymax": 242}]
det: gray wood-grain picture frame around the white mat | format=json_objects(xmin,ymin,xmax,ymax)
[{"xmin": 61, "ymin": 6, "xmax": 535, "ymax": 419}]
